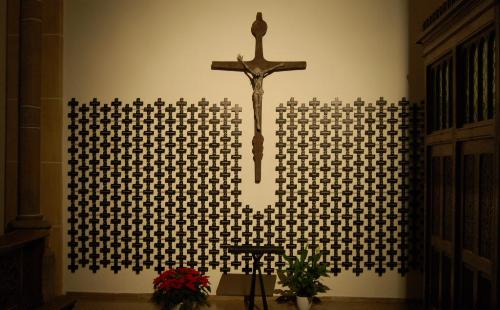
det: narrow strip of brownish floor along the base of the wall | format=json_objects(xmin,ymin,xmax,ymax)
[{"xmin": 75, "ymin": 296, "xmax": 418, "ymax": 310}]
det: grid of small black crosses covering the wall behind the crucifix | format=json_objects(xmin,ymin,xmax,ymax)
[{"xmin": 68, "ymin": 98, "xmax": 423, "ymax": 275}]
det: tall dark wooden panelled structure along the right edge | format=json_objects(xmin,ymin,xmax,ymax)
[{"xmin": 420, "ymin": 0, "xmax": 500, "ymax": 309}]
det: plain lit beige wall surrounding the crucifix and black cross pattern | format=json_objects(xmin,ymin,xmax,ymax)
[{"xmin": 61, "ymin": 0, "xmax": 409, "ymax": 297}]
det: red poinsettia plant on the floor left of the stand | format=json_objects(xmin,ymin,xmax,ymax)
[{"xmin": 153, "ymin": 267, "xmax": 210, "ymax": 310}]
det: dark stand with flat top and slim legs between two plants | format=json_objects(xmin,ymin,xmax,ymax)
[{"xmin": 227, "ymin": 245, "xmax": 285, "ymax": 310}]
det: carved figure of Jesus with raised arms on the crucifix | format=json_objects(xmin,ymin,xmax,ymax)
[{"xmin": 236, "ymin": 55, "xmax": 283, "ymax": 131}]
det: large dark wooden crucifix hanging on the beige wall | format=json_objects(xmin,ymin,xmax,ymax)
[{"xmin": 212, "ymin": 12, "xmax": 306, "ymax": 183}]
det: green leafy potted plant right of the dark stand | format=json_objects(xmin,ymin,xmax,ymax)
[{"xmin": 278, "ymin": 250, "xmax": 329, "ymax": 302}]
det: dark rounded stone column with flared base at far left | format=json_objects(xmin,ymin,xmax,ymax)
[{"xmin": 11, "ymin": 0, "xmax": 50, "ymax": 229}]
